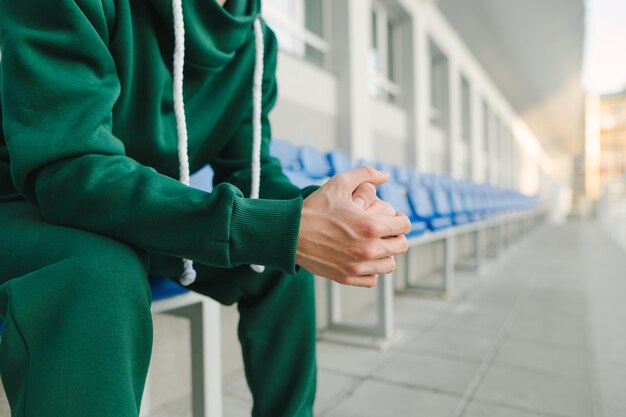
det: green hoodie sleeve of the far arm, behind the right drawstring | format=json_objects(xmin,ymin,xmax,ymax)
[{"xmin": 211, "ymin": 23, "xmax": 319, "ymax": 199}]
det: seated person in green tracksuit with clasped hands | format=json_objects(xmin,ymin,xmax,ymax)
[{"xmin": 0, "ymin": 0, "xmax": 410, "ymax": 417}]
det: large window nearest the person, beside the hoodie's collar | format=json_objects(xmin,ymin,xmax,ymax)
[{"xmin": 263, "ymin": 0, "xmax": 329, "ymax": 67}]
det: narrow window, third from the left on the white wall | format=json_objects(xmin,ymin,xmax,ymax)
[{"xmin": 429, "ymin": 41, "xmax": 448, "ymax": 128}]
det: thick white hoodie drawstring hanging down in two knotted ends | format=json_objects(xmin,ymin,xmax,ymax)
[{"xmin": 172, "ymin": 0, "xmax": 265, "ymax": 286}]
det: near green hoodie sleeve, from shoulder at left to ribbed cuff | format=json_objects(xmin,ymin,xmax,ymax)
[{"xmin": 0, "ymin": 0, "xmax": 302, "ymax": 273}]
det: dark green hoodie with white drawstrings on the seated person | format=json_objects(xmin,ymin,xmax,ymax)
[{"xmin": 0, "ymin": 0, "xmax": 312, "ymax": 273}]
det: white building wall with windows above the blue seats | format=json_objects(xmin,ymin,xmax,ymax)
[{"xmin": 269, "ymin": 0, "xmax": 549, "ymax": 194}]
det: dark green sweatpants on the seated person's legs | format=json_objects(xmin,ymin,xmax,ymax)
[{"xmin": 0, "ymin": 201, "xmax": 316, "ymax": 417}]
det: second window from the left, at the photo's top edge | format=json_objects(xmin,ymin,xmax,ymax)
[{"xmin": 369, "ymin": 3, "xmax": 400, "ymax": 103}]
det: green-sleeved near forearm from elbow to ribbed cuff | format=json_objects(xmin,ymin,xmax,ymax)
[{"xmin": 34, "ymin": 155, "xmax": 302, "ymax": 272}]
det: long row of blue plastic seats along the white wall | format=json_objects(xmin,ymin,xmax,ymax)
[{"xmin": 270, "ymin": 139, "xmax": 538, "ymax": 235}]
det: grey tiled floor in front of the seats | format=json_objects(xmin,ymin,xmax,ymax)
[{"xmin": 0, "ymin": 225, "xmax": 626, "ymax": 417}]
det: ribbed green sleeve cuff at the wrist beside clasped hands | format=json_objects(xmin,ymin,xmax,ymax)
[{"xmin": 230, "ymin": 197, "xmax": 302, "ymax": 274}]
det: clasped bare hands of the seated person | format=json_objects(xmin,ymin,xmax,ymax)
[{"xmin": 296, "ymin": 167, "xmax": 411, "ymax": 287}]
